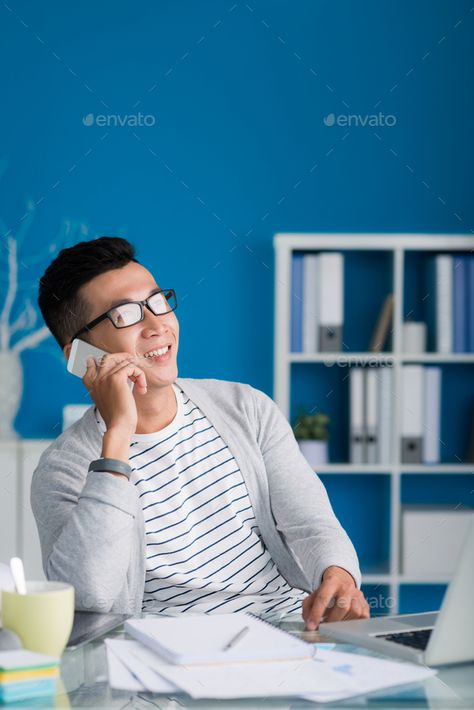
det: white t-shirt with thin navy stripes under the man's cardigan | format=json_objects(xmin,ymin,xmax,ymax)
[{"xmin": 95, "ymin": 384, "xmax": 306, "ymax": 618}]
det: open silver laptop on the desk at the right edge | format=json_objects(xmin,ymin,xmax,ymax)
[{"xmin": 319, "ymin": 515, "xmax": 474, "ymax": 666}]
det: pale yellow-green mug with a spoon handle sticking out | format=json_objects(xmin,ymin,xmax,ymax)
[{"xmin": 1, "ymin": 582, "xmax": 74, "ymax": 658}]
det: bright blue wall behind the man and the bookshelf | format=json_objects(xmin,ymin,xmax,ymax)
[{"xmin": 0, "ymin": 0, "xmax": 474, "ymax": 438}]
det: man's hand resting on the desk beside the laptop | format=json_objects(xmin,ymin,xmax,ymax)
[{"xmin": 302, "ymin": 567, "xmax": 370, "ymax": 631}]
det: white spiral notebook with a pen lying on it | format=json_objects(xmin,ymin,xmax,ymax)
[{"xmin": 125, "ymin": 612, "xmax": 313, "ymax": 664}]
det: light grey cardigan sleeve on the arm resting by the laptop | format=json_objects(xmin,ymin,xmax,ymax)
[{"xmin": 251, "ymin": 387, "xmax": 361, "ymax": 590}]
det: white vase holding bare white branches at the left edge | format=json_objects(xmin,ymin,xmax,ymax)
[{"xmin": 0, "ymin": 350, "xmax": 23, "ymax": 439}]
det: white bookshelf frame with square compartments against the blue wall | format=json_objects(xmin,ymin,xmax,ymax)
[{"xmin": 273, "ymin": 233, "xmax": 474, "ymax": 608}]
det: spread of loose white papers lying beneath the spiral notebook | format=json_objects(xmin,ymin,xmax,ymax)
[{"xmin": 106, "ymin": 639, "xmax": 435, "ymax": 703}]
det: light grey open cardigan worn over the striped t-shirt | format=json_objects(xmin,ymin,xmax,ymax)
[{"xmin": 31, "ymin": 378, "xmax": 360, "ymax": 614}]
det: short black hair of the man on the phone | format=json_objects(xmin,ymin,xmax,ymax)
[{"xmin": 38, "ymin": 237, "xmax": 139, "ymax": 350}]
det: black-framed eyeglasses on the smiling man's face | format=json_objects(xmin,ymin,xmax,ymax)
[{"xmin": 71, "ymin": 288, "xmax": 178, "ymax": 343}]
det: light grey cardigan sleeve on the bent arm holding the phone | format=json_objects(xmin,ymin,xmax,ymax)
[{"xmin": 31, "ymin": 447, "xmax": 136, "ymax": 613}]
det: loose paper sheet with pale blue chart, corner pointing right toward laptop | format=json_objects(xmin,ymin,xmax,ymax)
[{"xmin": 302, "ymin": 648, "xmax": 436, "ymax": 702}]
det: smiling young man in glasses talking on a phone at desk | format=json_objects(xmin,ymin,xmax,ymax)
[{"xmin": 31, "ymin": 237, "xmax": 369, "ymax": 629}]
